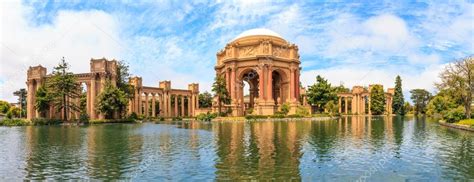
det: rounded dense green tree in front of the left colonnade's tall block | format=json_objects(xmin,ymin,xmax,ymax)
[{"xmin": 96, "ymin": 81, "xmax": 129, "ymax": 118}]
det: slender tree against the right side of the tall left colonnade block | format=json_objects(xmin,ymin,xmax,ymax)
[{"xmin": 117, "ymin": 61, "xmax": 135, "ymax": 117}]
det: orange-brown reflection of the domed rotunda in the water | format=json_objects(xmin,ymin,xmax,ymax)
[{"xmin": 216, "ymin": 121, "xmax": 302, "ymax": 180}]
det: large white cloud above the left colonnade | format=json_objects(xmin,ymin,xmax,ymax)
[{"xmin": 0, "ymin": 1, "xmax": 123, "ymax": 102}]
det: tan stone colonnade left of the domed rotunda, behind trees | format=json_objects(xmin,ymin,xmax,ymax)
[{"xmin": 26, "ymin": 58, "xmax": 199, "ymax": 119}]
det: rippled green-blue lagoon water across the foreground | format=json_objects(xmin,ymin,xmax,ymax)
[{"xmin": 0, "ymin": 117, "xmax": 474, "ymax": 181}]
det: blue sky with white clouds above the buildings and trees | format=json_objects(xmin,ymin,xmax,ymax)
[{"xmin": 0, "ymin": 0, "xmax": 474, "ymax": 102}]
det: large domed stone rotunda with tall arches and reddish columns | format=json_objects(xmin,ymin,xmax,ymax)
[{"xmin": 215, "ymin": 29, "xmax": 300, "ymax": 116}]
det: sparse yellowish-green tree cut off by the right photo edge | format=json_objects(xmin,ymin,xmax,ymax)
[{"xmin": 436, "ymin": 56, "xmax": 474, "ymax": 118}]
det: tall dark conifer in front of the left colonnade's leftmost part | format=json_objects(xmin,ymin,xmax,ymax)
[{"xmin": 47, "ymin": 57, "xmax": 80, "ymax": 120}]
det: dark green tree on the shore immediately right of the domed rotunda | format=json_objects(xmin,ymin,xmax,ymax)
[{"xmin": 306, "ymin": 75, "xmax": 337, "ymax": 112}]
